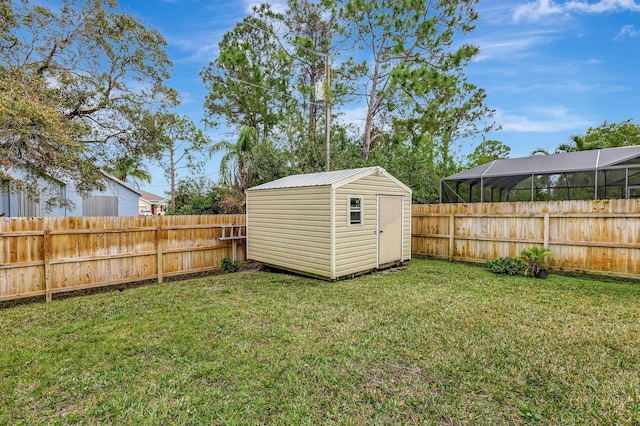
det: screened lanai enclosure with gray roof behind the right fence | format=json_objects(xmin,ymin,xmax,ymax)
[{"xmin": 440, "ymin": 146, "xmax": 640, "ymax": 203}]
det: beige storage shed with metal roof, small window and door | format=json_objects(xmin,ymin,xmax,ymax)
[{"xmin": 247, "ymin": 167, "xmax": 411, "ymax": 280}]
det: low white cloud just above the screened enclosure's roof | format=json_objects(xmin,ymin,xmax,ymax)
[{"xmin": 496, "ymin": 106, "xmax": 592, "ymax": 133}]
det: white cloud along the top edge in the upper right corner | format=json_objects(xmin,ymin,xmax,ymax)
[{"xmin": 513, "ymin": 0, "xmax": 640, "ymax": 22}]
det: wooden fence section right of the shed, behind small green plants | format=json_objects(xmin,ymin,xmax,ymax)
[{"xmin": 412, "ymin": 199, "xmax": 640, "ymax": 278}]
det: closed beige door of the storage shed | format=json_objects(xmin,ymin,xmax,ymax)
[{"xmin": 378, "ymin": 195, "xmax": 402, "ymax": 265}]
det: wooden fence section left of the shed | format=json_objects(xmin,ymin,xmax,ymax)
[{"xmin": 0, "ymin": 215, "xmax": 246, "ymax": 301}]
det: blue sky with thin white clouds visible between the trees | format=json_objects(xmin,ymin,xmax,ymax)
[{"xmin": 119, "ymin": 0, "xmax": 640, "ymax": 195}]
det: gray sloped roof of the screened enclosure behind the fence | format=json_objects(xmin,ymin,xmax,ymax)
[{"xmin": 444, "ymin": 146, "xmax": 640, "ymax": 182}]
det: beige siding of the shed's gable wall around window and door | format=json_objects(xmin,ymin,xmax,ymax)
[{"xmin": 335, "ymin": 174, "xmax": 411, "ymax": 278}]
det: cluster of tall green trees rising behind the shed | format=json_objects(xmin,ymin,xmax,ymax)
[{"xmin": 201, "ymin": 0, "xmax": 494, "ymax": 202}]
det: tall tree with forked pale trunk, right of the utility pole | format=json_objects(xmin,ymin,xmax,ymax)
[{"xmin": 341, "ymin": 0, "xmax": 493, "ymax": 161}]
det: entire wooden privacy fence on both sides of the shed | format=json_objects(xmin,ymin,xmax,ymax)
[{"xmin": 0, "ymin": 200, "xmax": 640, "ymax": 301}]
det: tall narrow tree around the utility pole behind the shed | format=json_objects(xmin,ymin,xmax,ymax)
[{"xmin": 278, "ymin": 0, "xmax": 358, "ymax": 173}]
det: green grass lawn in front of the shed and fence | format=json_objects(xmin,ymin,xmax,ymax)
[{"xmin": 0, "ymin": 259, "xmax": 640, "ymax": 425}]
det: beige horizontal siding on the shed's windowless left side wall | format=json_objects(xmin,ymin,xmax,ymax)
[{"xmin": 247, "ymin": 186, "xmax": 332, "ymax": 278}]
